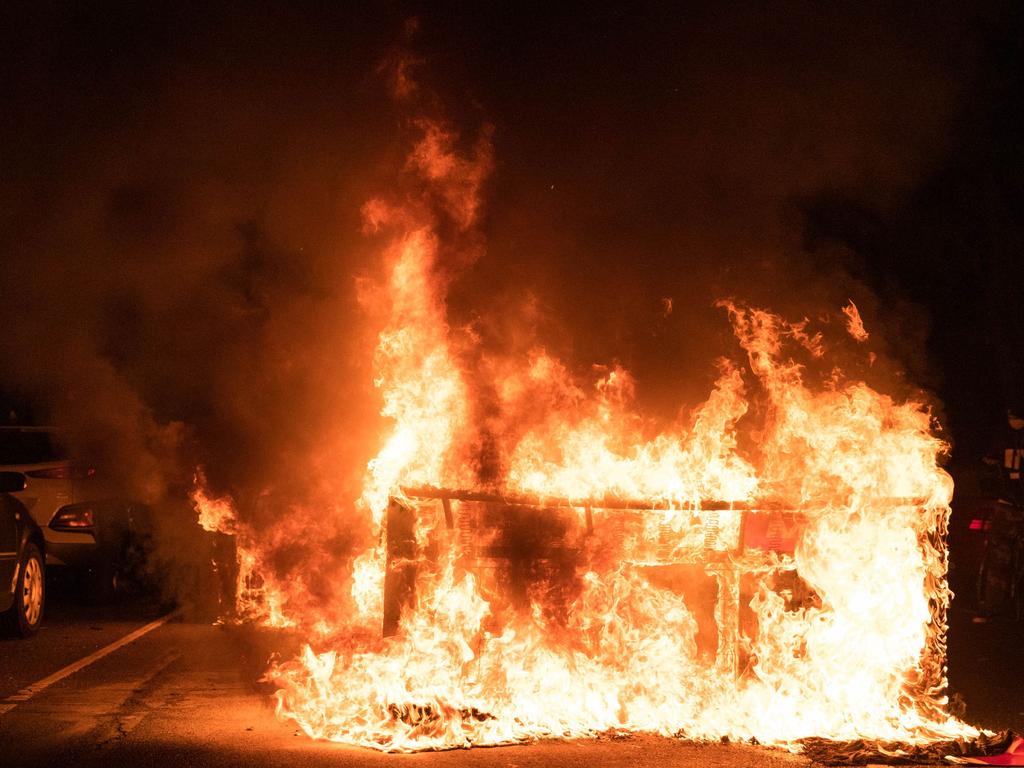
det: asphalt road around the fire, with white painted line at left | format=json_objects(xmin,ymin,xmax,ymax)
[{"xmin": 0, "ymin": 581, "xmax": 1024, "ymax": 768}]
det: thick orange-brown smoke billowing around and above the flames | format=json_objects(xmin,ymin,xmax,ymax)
[{"xmin": 0, "ymin": 4, "xmax": 983, "ymax": 606}]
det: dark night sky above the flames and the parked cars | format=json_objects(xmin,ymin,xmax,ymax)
[{"xmin": 0, "ymin": 3, "xmax": 1024, "ymax": 505}]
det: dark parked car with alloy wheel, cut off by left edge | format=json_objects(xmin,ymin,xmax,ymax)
[{"xmin": 0, "ymin": 472, "xmax": 46, "ymax": 637}]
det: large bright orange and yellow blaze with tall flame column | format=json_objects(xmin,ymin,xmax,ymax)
[{"xmin": 188, "ymin": 99, "xmax": 977, "ymax": 751}]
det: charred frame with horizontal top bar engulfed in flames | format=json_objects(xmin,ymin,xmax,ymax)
[{"xmin": 382, "ymin": 487, "xmax": 827, "ymax": 676}]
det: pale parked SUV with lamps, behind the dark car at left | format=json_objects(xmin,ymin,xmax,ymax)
[{"xmin": 0, "ymin": 426, "xmax": 146, "ymax": 600}]
